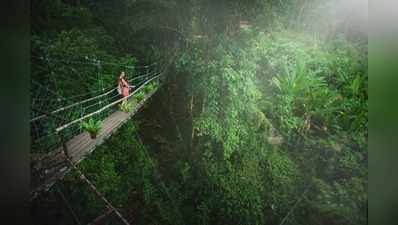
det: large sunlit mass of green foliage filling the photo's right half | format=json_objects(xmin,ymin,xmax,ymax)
[{"xmin": 177, "ymin": 30, "xmax": 367, "ymax": 224}]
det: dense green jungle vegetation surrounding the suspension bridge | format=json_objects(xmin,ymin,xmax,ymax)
[{"xmin": 31, "ymin": 0, "xmax": 368, "ymax": 225}]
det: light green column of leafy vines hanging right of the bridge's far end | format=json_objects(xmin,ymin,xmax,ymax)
[{"xmin": 180, "ymin": 32, "xmax": 261, "ymax": 158}]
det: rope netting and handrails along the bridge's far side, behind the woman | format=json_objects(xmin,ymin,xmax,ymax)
[{"xmin": 30, "ymin": 57, "xmax": 166, "ymax": 153}]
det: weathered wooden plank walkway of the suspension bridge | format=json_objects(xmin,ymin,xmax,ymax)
[{"xmin": 31, "ymin": 89, "xmax": 157, "ymax": 198}]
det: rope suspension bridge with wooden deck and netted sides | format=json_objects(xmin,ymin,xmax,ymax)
[{"xmin": 30, "ymin": 50, "xmax": 175, "ymax": 224}]
